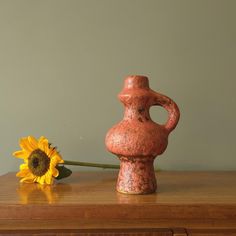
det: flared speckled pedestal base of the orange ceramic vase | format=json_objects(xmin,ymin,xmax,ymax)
[{"xmin": 116, "ymin": 157, "xmax": 157, "ymax": 194}]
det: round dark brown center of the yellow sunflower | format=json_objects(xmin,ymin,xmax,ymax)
[{"xmin": 28, "ymin": 149, "xmax": 50, "ymax": 176}]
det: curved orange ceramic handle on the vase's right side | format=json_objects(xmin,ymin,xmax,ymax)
[{"xmin": 151, "ymin": 90, "xmax": 180, "ymax": 133}]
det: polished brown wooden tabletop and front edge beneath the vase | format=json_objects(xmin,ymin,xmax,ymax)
[{"xmin": 0, "ymin": 171, "xmax": 236, "ymax": 236}]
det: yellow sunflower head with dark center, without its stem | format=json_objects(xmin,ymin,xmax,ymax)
[{"xmin": 13, "ymin": 136, "xmax": 64, "ymax": 184}]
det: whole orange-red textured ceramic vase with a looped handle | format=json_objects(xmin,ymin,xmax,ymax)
[{"xmin": 105, "ymin": 75, "xmax": 180, "ymax": 194}]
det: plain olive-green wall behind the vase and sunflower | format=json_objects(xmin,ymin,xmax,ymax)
[{"xmin": 0, "ymin": 0, "xmax": 236, "ymax": 173}]
